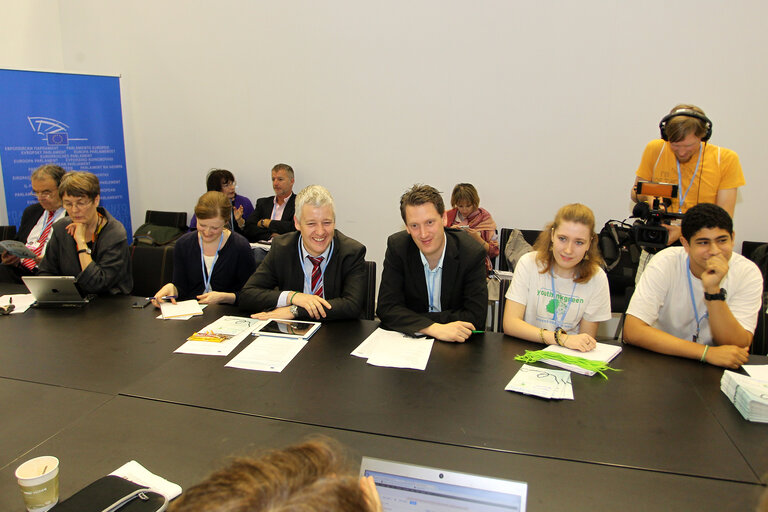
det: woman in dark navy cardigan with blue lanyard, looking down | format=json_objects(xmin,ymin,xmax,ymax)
[{"xmin": 152, "ymin": 191, "xmax": 256, "ymax": 306}]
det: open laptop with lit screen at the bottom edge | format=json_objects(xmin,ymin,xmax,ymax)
[{"xmin": 360, "ymin": 457, "xmax": 528, "ymax": 512}]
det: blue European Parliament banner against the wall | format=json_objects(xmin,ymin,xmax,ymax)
[{"xmin": 0, "ymin": 69, "xmax": 133, "ymax": 241}]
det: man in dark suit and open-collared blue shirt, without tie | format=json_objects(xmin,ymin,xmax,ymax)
[{"xmin": 376, "ymin": 185, "xmax": 488, "ymax": 342}]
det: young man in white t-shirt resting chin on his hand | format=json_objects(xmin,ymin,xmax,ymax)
[{"xmin": 624, "ymin": 203, "xmax": 763, "ymax": 368}]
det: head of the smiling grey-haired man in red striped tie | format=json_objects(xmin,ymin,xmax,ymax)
[{"xmin": 294, "ymin": 185, "xmax": 336, "ymax": 256}]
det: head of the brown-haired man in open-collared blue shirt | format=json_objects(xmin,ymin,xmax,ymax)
[{"xmin": 400, "ymin": 185, "xmax": 445, "ymax": 259}]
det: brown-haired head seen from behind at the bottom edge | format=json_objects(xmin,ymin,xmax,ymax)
[{"xmin": 169, "ymin": 439, "xmax": 381, "ymax": 512}]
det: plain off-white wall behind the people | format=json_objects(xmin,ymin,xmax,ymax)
[{"xmin": 0, "ymin": 0, "xmax": 768, "ymax": 276}]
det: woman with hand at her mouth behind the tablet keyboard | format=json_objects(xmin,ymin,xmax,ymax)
[{"xmin": 39, "ymin": 172, "xmax": 133, "ymax": 295}]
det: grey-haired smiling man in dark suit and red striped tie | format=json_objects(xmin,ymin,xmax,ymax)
[{"xmin": 240, "ymin": 185, "xmax": 367, "ymax": 321}]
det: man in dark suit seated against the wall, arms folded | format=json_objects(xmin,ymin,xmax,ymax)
[{"xmin": 243, "ymin": 164, "xmax": 296, "ymax": 242}]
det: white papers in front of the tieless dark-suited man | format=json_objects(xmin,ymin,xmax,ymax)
[{"xmin": 352, "ymin": 327, "xmax": 435, "ymax": 370}]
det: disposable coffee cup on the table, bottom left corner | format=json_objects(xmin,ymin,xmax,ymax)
[{"xmin": 16, "ymin": 455, "xmax": 59, "ymax": 512}]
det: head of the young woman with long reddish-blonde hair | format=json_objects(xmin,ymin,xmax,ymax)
[{"xmin": 534, "ymin": 203, "xmax": 603, "ymax": 283}]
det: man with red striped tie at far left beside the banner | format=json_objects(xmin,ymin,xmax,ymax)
[{"xmin": 0, "ymin": 164, "xmax": 66, "ymax": 283}]
